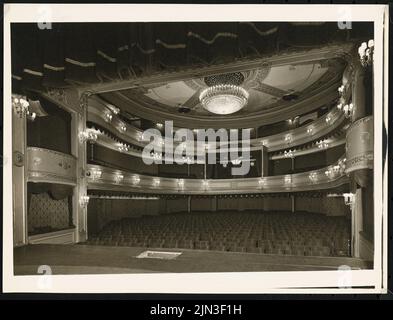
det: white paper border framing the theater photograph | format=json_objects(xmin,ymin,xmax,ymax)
[{"xmin": 3, "ymin": 4, "xmax": 389, "ymax": 294}]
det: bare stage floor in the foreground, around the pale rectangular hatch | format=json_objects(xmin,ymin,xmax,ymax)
[{"xmin": 14, "ymin": 244, "xmax": 372, "ymax": 275}]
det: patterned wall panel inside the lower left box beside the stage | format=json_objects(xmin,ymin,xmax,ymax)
[{"xmin": 28, "ymin": 193, "xmax": 70, "ymax": 234}]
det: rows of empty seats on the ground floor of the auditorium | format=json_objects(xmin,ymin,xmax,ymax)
[{"xmin": 88, "ymin": 211, "xmax": 350, "ymax": 256}]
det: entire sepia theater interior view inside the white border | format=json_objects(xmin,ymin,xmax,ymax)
[{"xmin": 11, "ymin": 22, "xmax": 374, "ymax": 275}]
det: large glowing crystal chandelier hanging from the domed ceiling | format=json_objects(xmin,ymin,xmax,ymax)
[{"xmin": 199, "ymin": 84, "xmax": 249, "ymax": 115}]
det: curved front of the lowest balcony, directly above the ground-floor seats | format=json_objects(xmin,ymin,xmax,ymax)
[{"xmin": 87, "ymin": 159, "xmax": 348, "ymax": 195}]
